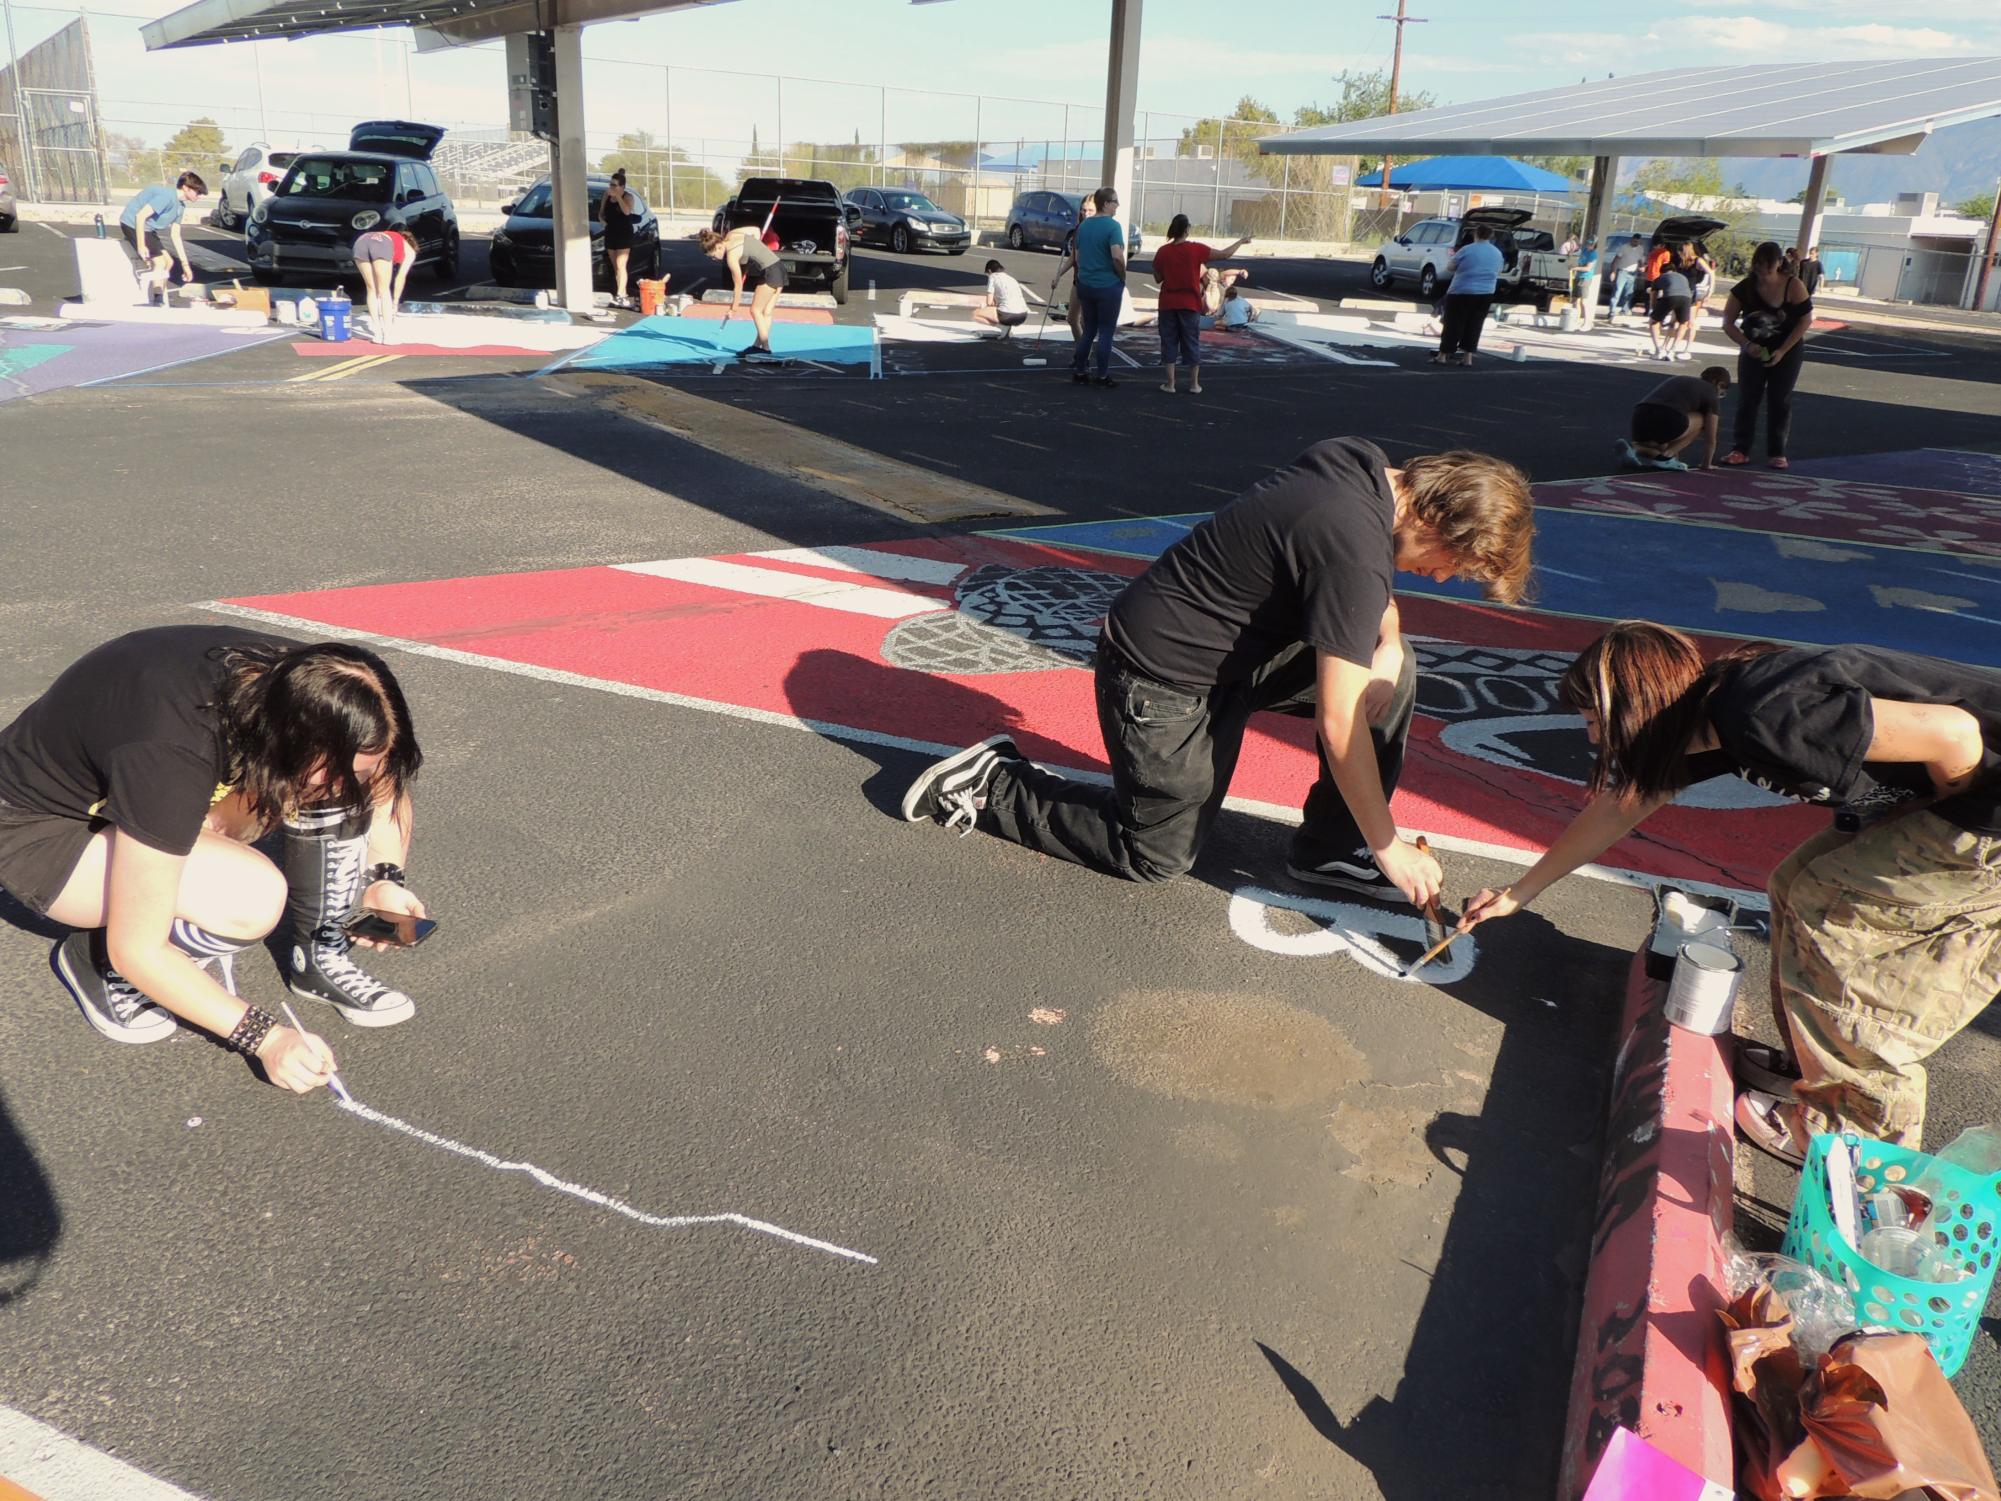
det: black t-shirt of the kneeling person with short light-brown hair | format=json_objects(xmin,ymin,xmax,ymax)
[{"xmin": 1105, "ymin": 438, "xmax": 1397, "ymax": 688}]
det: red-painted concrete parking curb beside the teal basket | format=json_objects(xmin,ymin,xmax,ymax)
[{"xmin": 1557, "ymin": 953, "xmax": 1735, "ymax": 1501}]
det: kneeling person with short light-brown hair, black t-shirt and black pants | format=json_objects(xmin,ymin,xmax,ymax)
[{"xmin": 902, "ymin": 438, "xmax": 1535, "ymax": 905}]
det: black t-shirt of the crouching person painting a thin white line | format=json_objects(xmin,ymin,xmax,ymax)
[{"xmin": 0, "ymin": 626, "xmax": 298, "ymax": 855}]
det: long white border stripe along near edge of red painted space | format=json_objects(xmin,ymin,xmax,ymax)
[{"xmin": 196, "ymin": 600, "xmax": 1767, "ymax": 911}]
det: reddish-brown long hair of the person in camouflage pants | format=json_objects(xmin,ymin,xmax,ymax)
[{"xmin": 1557, "ymin": 620, "xmax": 1779, "ymax": 801}]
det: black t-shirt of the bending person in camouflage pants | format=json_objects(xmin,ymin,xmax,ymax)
[{"xmin": 1689, "ymin": 646, "xmax": 2001, "ymax": 835}]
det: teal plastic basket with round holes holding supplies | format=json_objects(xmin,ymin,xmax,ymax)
[{"xmin": 1781, "ymin": 1133, "xmax": 2001, "ymax": 1377}]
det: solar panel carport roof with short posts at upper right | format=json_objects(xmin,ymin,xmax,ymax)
[{"xmin": 1259, "ymin": 58, "xmax": 2001, "ymax": 256}]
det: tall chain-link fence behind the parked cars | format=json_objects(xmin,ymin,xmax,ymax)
[{"xmin": 14, "ymin": 0, "xmax": 1384, "ymax": 244}]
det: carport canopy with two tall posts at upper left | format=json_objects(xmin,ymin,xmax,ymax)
[{"xmin": 140, "ymin": 0, "xmax": 1145, "ymax": 312}]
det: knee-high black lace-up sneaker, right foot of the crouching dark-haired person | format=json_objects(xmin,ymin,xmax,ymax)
[{"xmin": 284, "ymin": 809, "xmax": 416, "ymax": 1027}]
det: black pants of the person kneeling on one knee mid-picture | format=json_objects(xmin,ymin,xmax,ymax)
[{"xmin": 978, "ymin": 642, "xmax": 1417, "ymax": 881}]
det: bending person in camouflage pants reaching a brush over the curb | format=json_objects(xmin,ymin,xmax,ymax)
[{"xmin": 1459, "ymin": 620, "xmax": 2001, "ymax": 1165}]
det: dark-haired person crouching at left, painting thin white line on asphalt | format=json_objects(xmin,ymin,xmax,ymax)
[{"xmin": 0, "ymin": 626, "xmax": 424, "ymax": 1093}]
